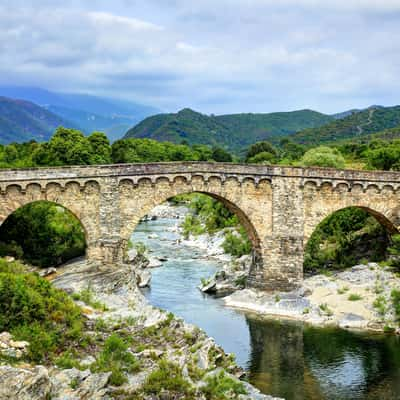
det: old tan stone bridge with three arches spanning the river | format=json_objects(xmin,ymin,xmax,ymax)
[{"xmin": 0, "ymin": 162, "xmax": 400, "ymax": 290}]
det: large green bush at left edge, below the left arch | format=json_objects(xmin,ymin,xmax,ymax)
[{"xmin": 0, "ymin": 259, "xmax": 83, "ymax": 362}]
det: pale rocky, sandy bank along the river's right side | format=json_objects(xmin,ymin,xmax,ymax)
[{"xmin": 149, "ymin": 206, "xmax": 400, "ymax": 333}]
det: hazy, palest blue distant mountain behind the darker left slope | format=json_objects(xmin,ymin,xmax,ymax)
[{"xmin": 0, "ymin": 86, "xmax": 159, "ymax": 140}]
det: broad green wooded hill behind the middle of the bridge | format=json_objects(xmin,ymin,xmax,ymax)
[{"xmin": 124, "ymin": 108, "xmax": 333, "ymax": 151}]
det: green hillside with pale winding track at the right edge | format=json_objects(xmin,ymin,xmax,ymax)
[{"xmin": 290, "ymin": 106, "xmax": 400, "ymax": 146}]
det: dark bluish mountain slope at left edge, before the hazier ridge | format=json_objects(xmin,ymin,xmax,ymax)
[{"xmin": 0, "ymin": 97, "xmax": 73, "ymax": 144}]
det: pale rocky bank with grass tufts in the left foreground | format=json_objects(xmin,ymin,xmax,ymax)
[{"xmin": 0, "ymin": 260, "xmax": 282, "ymax": 400}]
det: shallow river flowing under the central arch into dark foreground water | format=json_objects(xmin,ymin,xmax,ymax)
[{"xmin": 132, "ymin": 214, "xmax": 400, "ymax": 400}]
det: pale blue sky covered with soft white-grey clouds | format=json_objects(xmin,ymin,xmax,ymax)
[{"xmin": 0, "ymin": 0, "xmax": 400, "ymax": 114}]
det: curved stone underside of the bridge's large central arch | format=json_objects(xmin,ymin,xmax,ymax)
[{"xmin": 124, "ymin": 190, "xmax": 262, "ymax": 268}]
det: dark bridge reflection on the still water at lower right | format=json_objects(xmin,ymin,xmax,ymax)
[{"xmin": 246, "ymin": 316, "xmax": 400, "ymax": 400}]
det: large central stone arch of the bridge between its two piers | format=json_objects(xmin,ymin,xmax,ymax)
[{"xmin": 115, "ymin": 176, "xmax": 271, "ymax": 284}]
